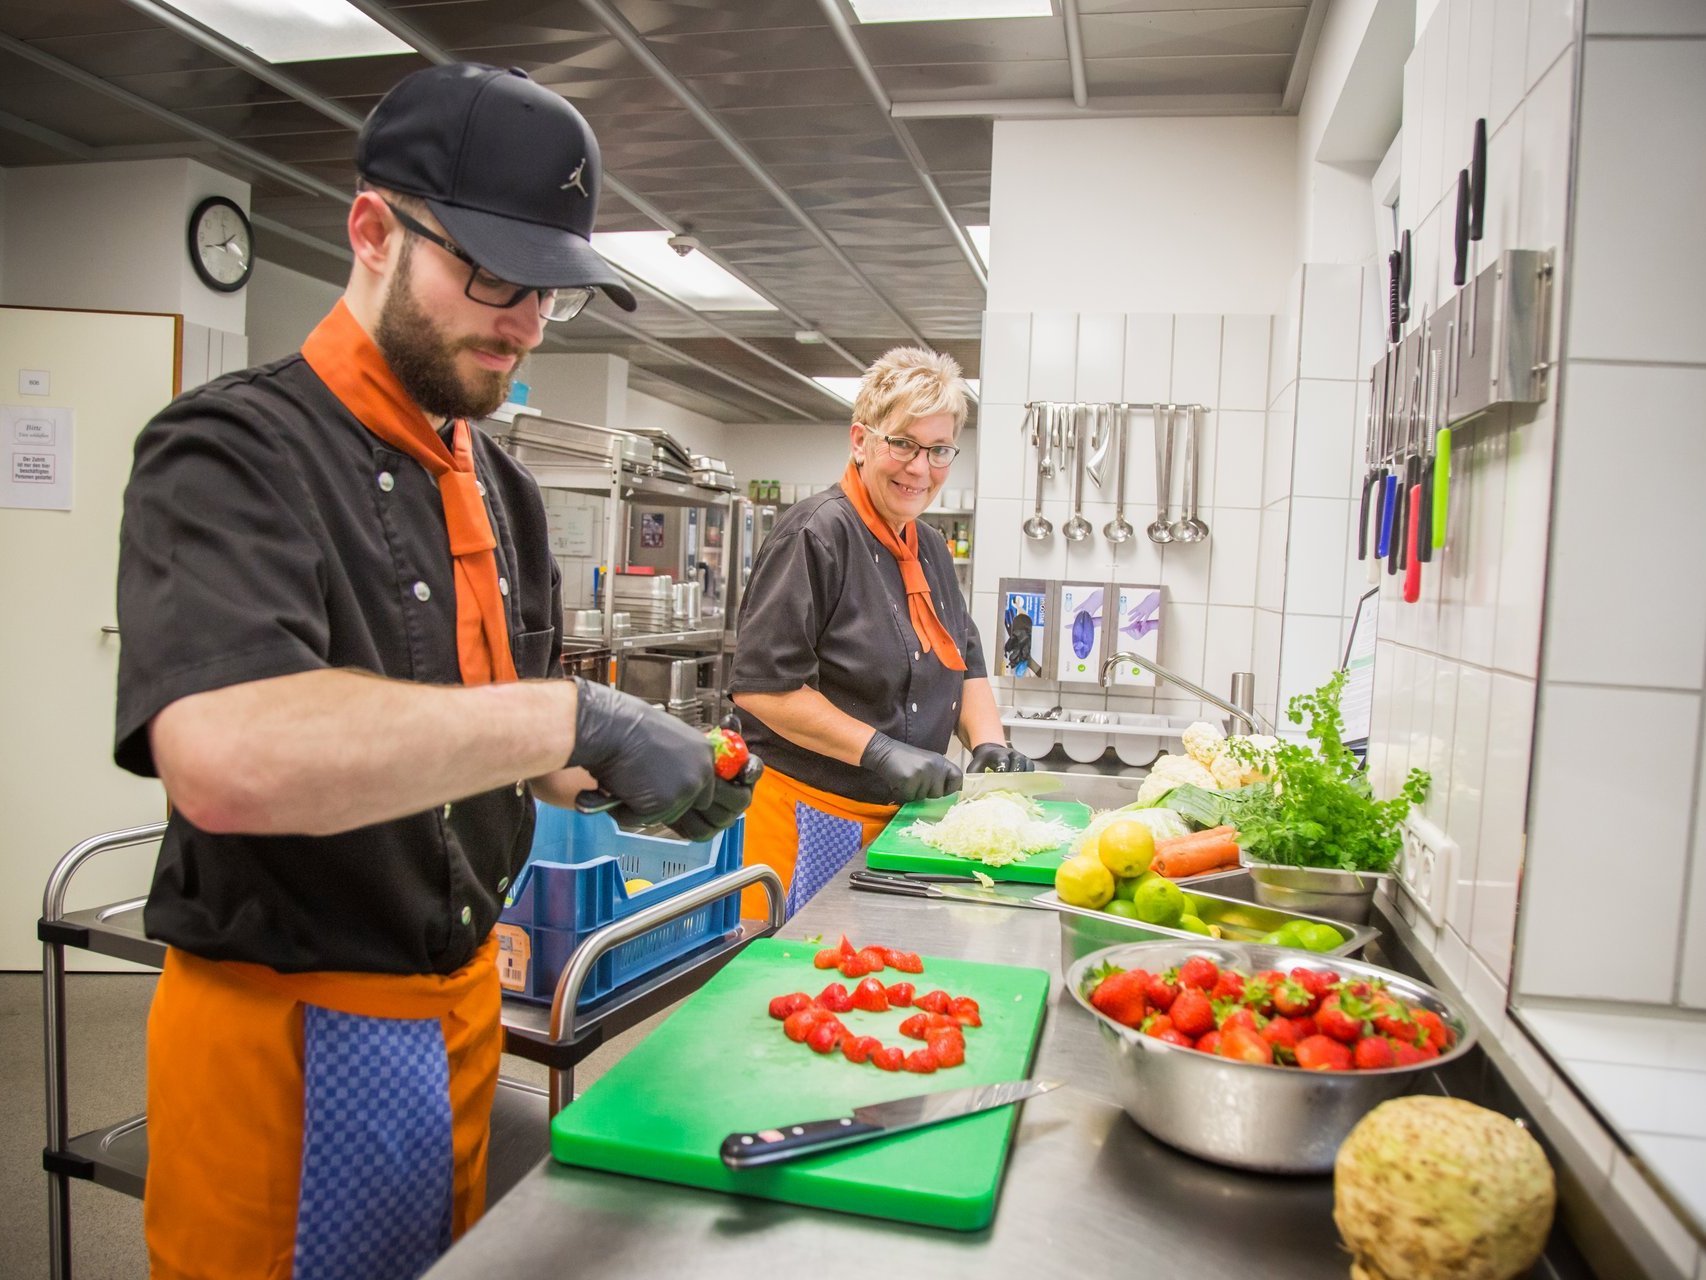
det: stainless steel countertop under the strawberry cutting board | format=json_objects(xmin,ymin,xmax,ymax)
[{"xmin": 428, "ymin": 846, "xmax": 1348, "ymax": 1280}]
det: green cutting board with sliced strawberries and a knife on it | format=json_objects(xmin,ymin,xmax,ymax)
[{"xmin": 551, "ymin": 939, "xmax": 1049, "ymax": 1231}]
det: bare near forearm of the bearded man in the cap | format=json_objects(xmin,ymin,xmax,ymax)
[{"xmin": 148, "ymin": 671, "xmax": 577, "ymax": 835}]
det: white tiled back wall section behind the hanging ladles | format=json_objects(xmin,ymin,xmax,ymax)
[{"xmin": 972, "ymin": 312, "xmax": 1285, "ymax": 713}]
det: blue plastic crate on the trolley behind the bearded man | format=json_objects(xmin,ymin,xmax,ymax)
[{"xmin": 498, "ymin": 804, "xmax": 746, "ymax": 1009}]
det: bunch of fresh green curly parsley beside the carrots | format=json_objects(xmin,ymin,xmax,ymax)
[{"xmin": 1227, "ymin": 671, "xmax": 1433, "ymax": 872}]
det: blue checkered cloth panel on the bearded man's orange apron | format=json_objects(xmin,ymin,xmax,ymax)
[{"xmin": 293, "ymin": 1005, "xmax": 454, "ymax": 1280}]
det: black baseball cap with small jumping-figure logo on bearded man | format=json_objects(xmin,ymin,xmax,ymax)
[{"xmin": 355, "ymin": 63, "xmax": 635, "ymax": 311}]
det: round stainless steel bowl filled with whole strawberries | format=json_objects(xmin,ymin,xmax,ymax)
[{"xmin": 1066, "ymin": 939, "xmax": 1476, "ymax": 1174}]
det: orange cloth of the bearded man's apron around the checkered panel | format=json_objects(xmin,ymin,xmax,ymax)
[{"xmin": 143, "ymin": 937, "xmax": 503, "ymax": 1280}]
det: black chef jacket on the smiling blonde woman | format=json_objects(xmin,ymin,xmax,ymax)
[{"xmin": 730, "ymin": 486, "xmax": 984, "ymax": 804}]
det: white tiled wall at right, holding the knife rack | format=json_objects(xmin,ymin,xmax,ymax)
[{"xmin": 1371, "ymin": 0, "xmax": 1706, "ymax": 1277}]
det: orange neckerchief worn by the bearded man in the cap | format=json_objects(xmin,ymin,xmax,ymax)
[{"xmin": 302, "ymin": 299, "xmax": 515, "ymax": 684}]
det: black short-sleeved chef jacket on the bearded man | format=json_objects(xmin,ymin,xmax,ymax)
[{"xmin": 113, "ymin": 355, "xmax": 563, "ymax": 975}]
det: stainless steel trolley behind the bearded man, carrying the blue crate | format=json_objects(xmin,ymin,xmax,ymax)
[{"xmin": 36, "ymin": 823, "xmax": 785, "ymax": 1280}]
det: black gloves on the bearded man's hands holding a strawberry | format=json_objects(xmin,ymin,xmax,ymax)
[{"xmin": 568, "ymin": 679, "xmax": 764, "ymax": 840}]
